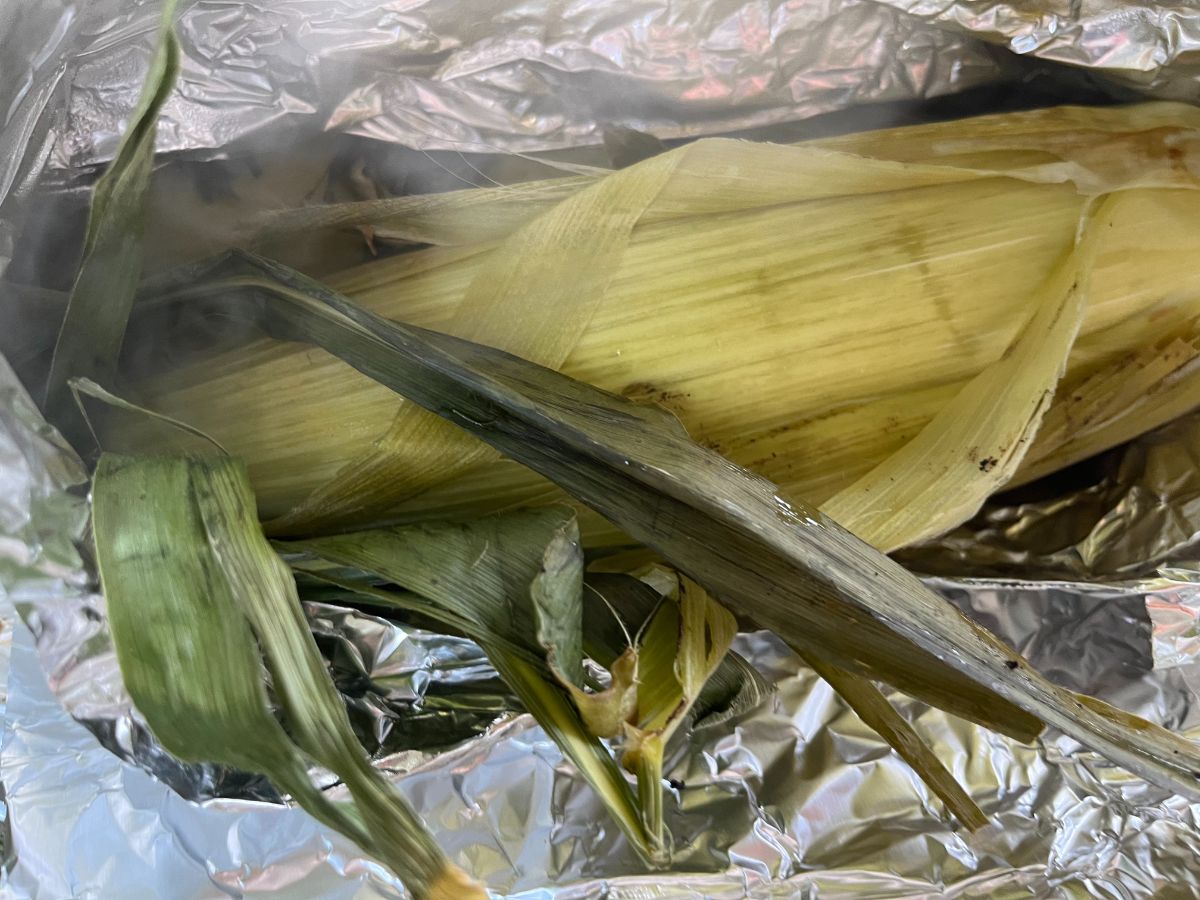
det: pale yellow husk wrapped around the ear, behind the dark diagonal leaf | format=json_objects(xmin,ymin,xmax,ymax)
[{"xmin": 131, "ymin": 104, "xmax": 1200, "ymax": 541}]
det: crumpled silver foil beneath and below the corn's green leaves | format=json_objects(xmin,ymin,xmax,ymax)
[{"xmin": 0, "ymin": 360, "xmax": 1200, "ymax": 900}]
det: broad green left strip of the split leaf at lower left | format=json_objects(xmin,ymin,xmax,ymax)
[{"xmin": 92, "ymin": 456, "xmax": 357, "ymax": 846}]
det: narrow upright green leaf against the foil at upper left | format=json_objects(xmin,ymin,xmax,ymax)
[{"xmin": 46, "ymin": 0, "xmax": 179, "ymax": 446}]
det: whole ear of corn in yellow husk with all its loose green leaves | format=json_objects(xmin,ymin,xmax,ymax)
[{"xmin": 68, "ymin": 28, "xmax": 1200, "ymax": 883}]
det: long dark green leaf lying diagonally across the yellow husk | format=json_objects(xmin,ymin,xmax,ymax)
[{"xmin": 142, "ymin": 248, "xmax": 1200, "ymax": 797}]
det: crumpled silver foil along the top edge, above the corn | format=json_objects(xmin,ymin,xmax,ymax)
[{"xmin": 0, "ymin": 0, "xmax": 1200, "ymax": 187}]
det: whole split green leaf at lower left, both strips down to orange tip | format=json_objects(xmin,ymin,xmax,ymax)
[{"xmin": 92, "ymin": 454, "xmax": 484, "ymax": 898}]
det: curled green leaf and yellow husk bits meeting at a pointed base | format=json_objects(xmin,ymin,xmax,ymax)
[{"xmin": 280, "ymin": 506, "xmax": 744, "ymax": 864}]
